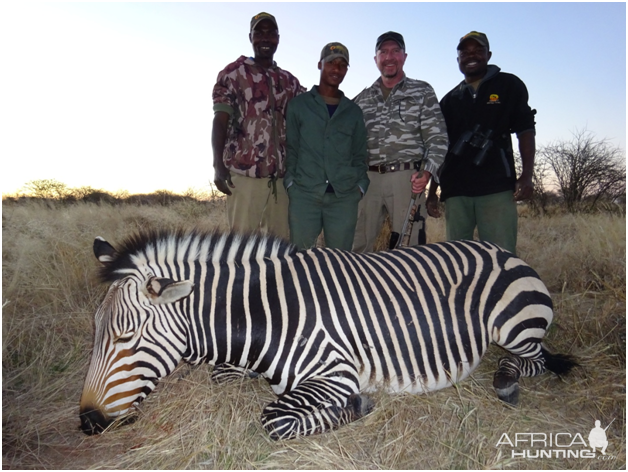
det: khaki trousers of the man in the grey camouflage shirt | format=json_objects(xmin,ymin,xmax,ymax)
[{"xmin": 353, "ymin": 169, "xmax": 427, "ymax": 252}]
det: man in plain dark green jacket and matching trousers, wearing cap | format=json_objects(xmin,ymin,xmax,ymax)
[{"xmin": 284, "ymin": 43, "xmax": 369, "ymax": 250}]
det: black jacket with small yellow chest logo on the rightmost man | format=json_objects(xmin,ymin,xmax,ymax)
[{"xmin": 440, "ymin": 65, "xmax": 536, "ymax": 201}]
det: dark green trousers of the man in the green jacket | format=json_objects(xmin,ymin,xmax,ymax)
[{"xmin": 288, "ymin": 184, "xmax": 361, "ymax": 251}]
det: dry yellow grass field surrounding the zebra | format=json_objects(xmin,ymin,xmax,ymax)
[{"xmin": 2, "ymin": 201, "xmax": 626, "ymax": 469}]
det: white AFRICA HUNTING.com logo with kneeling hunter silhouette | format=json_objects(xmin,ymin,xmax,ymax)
[{"xmin": 495, "ymin": 419, "xmax": 617, "ymax": 460}]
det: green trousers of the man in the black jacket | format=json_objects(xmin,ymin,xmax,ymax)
[{"xmin": 445, "ymin": 191, "xmax": 517, "ymax": 254}]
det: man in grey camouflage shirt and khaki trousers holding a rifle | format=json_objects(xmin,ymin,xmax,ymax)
[{"xmin": 353, "ymin": 31, "xmax": 448, "ymax": 252}]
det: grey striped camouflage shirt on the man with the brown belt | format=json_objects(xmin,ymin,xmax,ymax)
[{"xmin": 353, "ymin": 76, "xmax": 448, "ymax": 179}]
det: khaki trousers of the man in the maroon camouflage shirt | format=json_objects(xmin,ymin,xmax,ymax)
[{"xmin": 227, "ymin": 173, "xmax": 290, "ymax": 240}]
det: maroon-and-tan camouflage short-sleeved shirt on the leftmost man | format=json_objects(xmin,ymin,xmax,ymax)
[{"xmin": 212, "ymin": 56, "xmax": 304, "ymax": 178}]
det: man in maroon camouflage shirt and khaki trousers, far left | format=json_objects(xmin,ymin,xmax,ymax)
[{"xmin": 212, "ymin": 12, "xmax": 304, "ymax": 239}]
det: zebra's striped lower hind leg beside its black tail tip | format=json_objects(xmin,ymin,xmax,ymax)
[{"xmin": 493, "ymin": 350, "xmax": 545, "ymax": 406}]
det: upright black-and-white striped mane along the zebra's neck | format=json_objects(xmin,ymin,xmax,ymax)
[{"xmin": 99, "ymin": 229, "xmax": 297, "ymax": 282}]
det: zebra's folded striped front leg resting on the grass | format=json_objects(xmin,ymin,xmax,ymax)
[{"xmin": 262, "ymin": 377, "xmax": 374, "ymax": 440}]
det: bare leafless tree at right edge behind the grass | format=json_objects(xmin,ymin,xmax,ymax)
[{"xmin": 537, "ymin": 130, "xmax": 626, "ymax": 212}]
